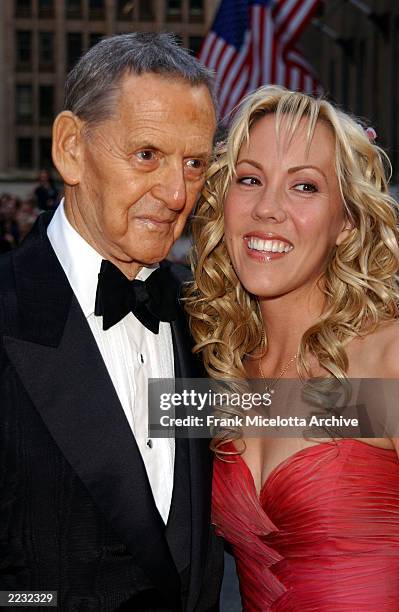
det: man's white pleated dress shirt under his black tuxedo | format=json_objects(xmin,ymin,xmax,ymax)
[{"xmin": 47, "ymin": 201, "xmax": 175, "ymax": 523}]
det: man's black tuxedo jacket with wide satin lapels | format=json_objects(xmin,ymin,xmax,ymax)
[{"xmin": 0, "ymin": 213, "xmax": 222, "ymax": 612}]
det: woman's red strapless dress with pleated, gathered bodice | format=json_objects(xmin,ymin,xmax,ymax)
[{"xmin": 213, "ymin": 439, "xmax": 399, "ymax": 612}]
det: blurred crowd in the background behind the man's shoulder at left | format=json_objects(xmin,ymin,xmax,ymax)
[{"xmin": 0, "ymin": 170, "xmax": 60, "ymax": 253}]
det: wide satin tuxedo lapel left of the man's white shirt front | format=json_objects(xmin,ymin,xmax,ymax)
[{"xmin": 5, "ymin": 218, "xmax": 180, "ymax": 609}]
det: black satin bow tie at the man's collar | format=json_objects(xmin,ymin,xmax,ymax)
[{"xmin": 94, "ymin": 261, "xmax": 176, "ymax": 334}]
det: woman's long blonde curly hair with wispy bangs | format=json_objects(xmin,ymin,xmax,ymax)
[{"xmin": 185, "ymin": 86, "xmax": 399, "ymax": 388}]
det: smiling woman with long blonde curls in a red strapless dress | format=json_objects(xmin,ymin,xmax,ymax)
[{"xmin": 187, "ymin": 87, "xmax": 399, "ymax": 612}]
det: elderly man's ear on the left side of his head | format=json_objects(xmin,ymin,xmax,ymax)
[{"xmin": 52, "ymin": 111, "xmax": 83, "ymax": 185}]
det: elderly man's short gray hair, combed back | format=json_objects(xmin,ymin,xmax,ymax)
[{"xmin": 64, "ymin": 32, "xmax": 216, "ymax": 124}]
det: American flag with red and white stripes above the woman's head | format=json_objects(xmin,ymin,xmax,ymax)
[{"xmin": 199, "ymin": 0, "xmax": 321, "ymax": 117}]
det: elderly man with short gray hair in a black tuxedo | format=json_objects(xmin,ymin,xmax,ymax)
[{"xmin": 0, "ymin": 34, "xmax": 221, "ymax": 612}]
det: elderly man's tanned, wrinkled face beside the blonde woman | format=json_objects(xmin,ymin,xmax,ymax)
[{"xmin": 67, "ymin": 73, "xmax": 215, "ymax": 266}]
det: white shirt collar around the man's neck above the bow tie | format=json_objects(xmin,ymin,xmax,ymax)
[{"xmin": 47, "ymin": 198, "xmax": 159, "ymax": 318}]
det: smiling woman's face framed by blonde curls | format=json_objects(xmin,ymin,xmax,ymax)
[{"xmin": 224, "ymin": 115, "xmax": 350, "ymax": 298}]
